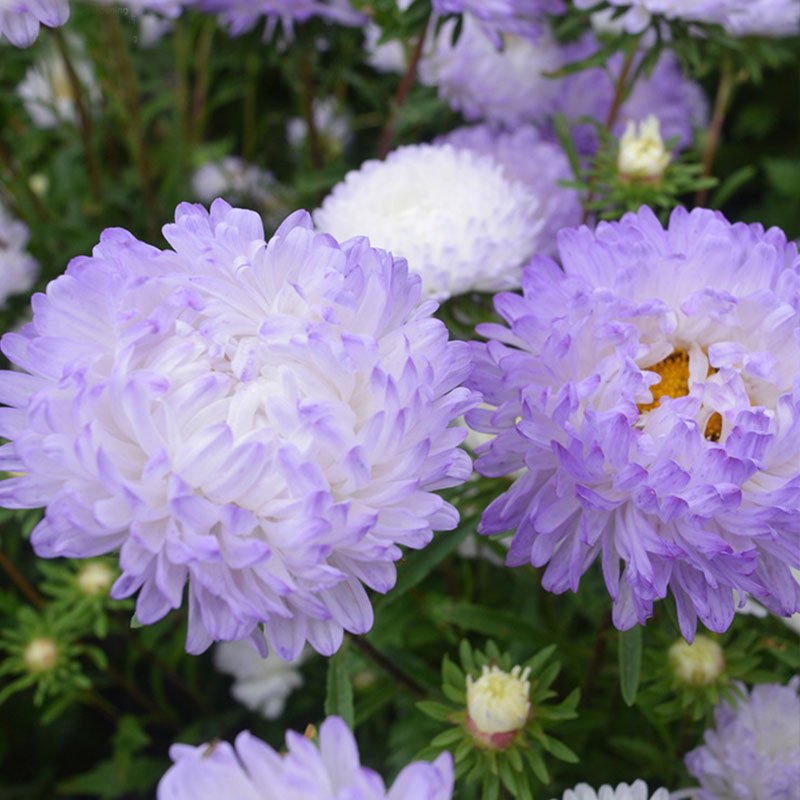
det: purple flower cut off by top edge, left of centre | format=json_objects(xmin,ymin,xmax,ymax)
[{"xmin": 186, "ymin": 0, "xmax": 365, "ymax": 36}]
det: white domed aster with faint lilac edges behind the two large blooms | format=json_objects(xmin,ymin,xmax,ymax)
[{"xmin": 314, "ymin": 144, "xmax": 544, "ymax": 300}]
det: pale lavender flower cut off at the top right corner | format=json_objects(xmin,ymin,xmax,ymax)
[{"xmin": 575, "ymin": 0, "xmax": 800, "ymax": 36}]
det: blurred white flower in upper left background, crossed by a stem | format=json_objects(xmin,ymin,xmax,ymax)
[{"xmin": 17, "ymin": 36, "xmax": 102, "ymax": 129}]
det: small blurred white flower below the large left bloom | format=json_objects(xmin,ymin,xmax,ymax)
[{"xmin": 214, "ymin": 639, "xmax": 306, "ymax": 719}]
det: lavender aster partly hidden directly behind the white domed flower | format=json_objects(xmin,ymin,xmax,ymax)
[{"xmin": 439, "ymin": 125, "xmax": 582, "ymax": 255}]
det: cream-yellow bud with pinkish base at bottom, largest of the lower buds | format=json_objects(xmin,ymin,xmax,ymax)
[{"xmin": 467, "ymin": 665, "xmax": 531, "ymax": 747}]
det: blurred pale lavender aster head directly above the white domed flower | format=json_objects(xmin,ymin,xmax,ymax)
[{"xmin": 419, "ymin": 14, "xmax": 563, "ymax": 128}]
